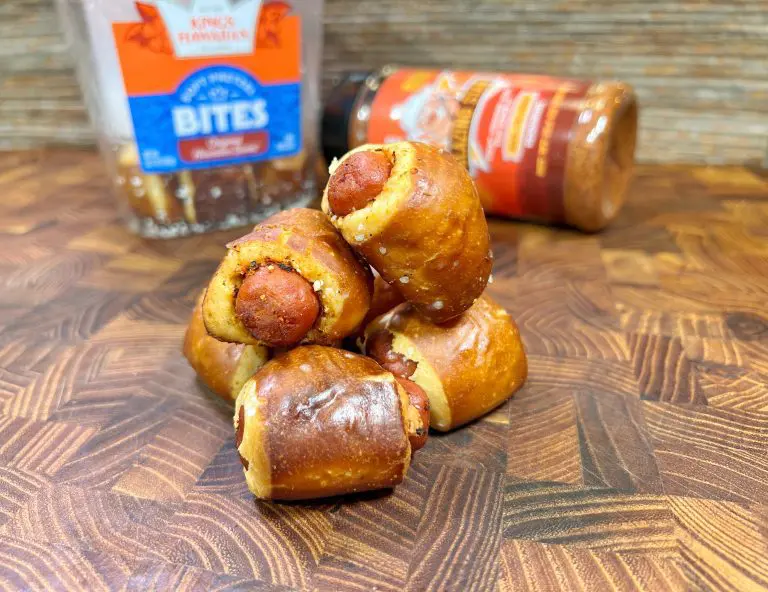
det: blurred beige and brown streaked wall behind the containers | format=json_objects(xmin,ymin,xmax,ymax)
[{"xmin": 0, "ymin": 0, "xmax": 768, "ymax": 164}]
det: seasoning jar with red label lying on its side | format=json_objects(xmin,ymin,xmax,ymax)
[{"xmin": 323, "ymin": 67, "xmax": 638, "ymax": 231}]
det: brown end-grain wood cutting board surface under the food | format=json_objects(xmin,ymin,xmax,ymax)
[{"xmin": 0, "ymin": 152, "xmax": 768, "ymax": 591}]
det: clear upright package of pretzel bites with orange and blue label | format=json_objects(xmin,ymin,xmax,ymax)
[{"xmin": 58, "ymin": 0, "xmax": 323, "ymax": 238}]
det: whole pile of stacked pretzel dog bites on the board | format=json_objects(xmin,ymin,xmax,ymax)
[{"xmin": 184, "ymin": 142, "xmax": 527, "ymax": 500}]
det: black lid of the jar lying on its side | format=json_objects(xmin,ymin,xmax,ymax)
[{"xmin": 321, "ymin": 72, "xmax": 371, "ymax": 163}]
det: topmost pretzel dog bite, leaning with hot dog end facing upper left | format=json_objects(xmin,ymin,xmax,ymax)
[{"xmin": 322, "ymin": 142, "xmax": 492, "ymax": 323}]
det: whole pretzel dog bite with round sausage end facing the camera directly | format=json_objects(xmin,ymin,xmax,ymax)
[{"xmin": 203, "ymin": 208, "xmax": 373, "ymax": 347}]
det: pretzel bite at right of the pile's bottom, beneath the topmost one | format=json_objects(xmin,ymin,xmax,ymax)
[{"xmin": 364, "ymin": 295, "xmax": 528, "ymax": 431}]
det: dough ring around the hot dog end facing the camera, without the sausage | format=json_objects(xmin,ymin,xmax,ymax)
[{"xmin": 203, "ymin": 208, "xmax": 373, "ymax": 346}]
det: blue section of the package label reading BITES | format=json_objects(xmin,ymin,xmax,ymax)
[{"xmin": 128, "ymin": 66, "xmax": 302, "ymax": 173}]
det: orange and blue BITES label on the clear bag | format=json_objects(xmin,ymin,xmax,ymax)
[{"xmin": 112, "ymin": 0, "xmax": 302, "ymax": 173}]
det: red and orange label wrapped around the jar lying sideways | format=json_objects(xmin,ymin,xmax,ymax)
[{"xmin": 367, "ymin": 69, "xmax": 590, "ymax": 222}]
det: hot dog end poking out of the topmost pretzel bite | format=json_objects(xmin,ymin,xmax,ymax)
[{"xmin": 328, "ymin": 152, "xmax": 392, "ymax": 216}]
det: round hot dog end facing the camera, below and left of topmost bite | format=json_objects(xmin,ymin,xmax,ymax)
[{"xmin": 235, "ymin": 265, "xmax": 320, "ymax": 347}]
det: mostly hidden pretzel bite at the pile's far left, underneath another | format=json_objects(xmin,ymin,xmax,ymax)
[{"xmin": 184, "ymin": 294, "xmax": 269, "ymax": 401}]
